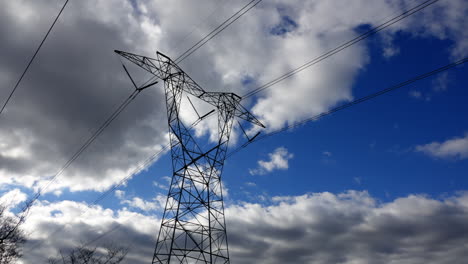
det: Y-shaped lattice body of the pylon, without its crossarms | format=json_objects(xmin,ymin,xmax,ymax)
[{"xmin": 153, "ymin": 72, "xmax": 233, "ymax": 264}]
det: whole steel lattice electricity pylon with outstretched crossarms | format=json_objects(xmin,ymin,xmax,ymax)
[{"xmin": 115, "ymin": 50, "xmax": 264, "ymax": 264}]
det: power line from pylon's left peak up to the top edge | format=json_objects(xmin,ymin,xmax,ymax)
[{"xmin": 174, "ymin": 0, "xmax": 262, "ymax": 63}]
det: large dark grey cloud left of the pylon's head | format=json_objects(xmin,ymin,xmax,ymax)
[{"xmin": 0, "ymin": 0, "xmax": 167, "ymax": 192}]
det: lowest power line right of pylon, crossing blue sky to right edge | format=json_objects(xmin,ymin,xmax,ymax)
[{"xmin": 231, "ymin": 57, "xmax": 468, "ymax": 158}]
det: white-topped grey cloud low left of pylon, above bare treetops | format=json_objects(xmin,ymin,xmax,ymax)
[{"xmin": 21, "ymin": 201, "xmax": 155, "ymax": 264}]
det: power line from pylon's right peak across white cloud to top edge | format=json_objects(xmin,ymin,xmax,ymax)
[{"xmin": 242, "ymin": 0, "xmax": 439, "ymax": 98}]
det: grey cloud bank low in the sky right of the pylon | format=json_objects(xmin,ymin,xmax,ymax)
[{"xmin": 226, "ymin": 191, "xmax": 468, "ymax": 264}]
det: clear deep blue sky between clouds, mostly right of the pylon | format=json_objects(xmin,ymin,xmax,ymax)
[{"xmin": 113, "ymin": 29, "xmax": 468, "ymax": 206}]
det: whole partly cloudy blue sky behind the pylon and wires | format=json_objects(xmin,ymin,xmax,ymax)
[{"xmin": 0, "ymin": 0, "xmax": 468, "ymax": 264}]
